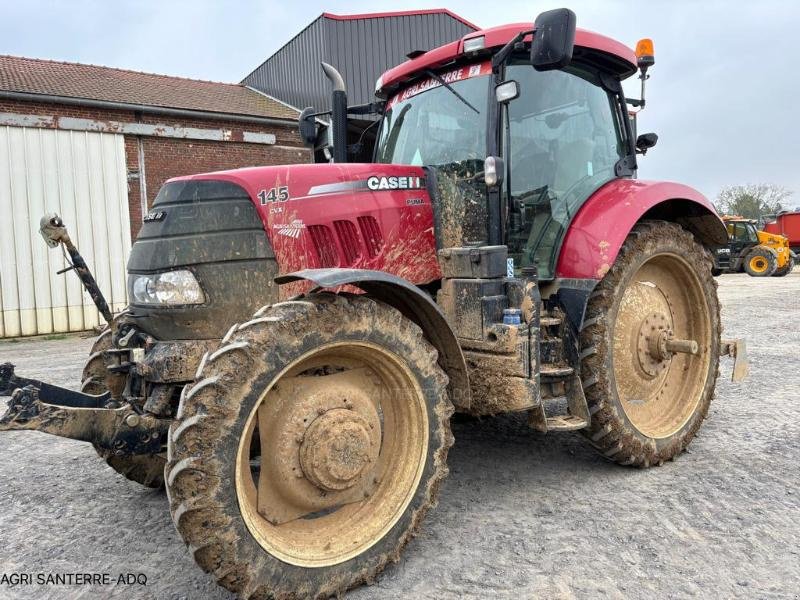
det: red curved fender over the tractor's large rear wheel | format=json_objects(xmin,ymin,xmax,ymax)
[{"xmin": 556, "ymin": 179, "xmax": 728, "ymax": 280}]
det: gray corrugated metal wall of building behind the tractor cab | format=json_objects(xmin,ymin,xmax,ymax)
[{"xmin": 242, "ymin": 13, "xmax": 474, "ymax": 110}]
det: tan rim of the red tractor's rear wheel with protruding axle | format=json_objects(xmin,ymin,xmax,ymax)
[{"xmin": 612, "ymin": 254, "xmax": 712, "ymax": 439}]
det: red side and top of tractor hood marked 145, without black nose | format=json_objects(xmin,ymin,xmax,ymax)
[{"xmin": 171, "ymin": 163, "xmax": 441, "ymax": 297}]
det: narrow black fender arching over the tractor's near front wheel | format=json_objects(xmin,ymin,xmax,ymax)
[{"xmin": 275, "ymin": 269, "xmax": 471, "ymax": 410}]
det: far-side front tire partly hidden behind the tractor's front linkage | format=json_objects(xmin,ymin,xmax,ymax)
[{"xmin": 81, "ymin": 328, "xmax": 166, "ymax": 488}]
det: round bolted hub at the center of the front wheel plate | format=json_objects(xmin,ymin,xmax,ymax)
[{"xmin": 300, "ymin": 408, "xmax": 378, "ymax": 491}]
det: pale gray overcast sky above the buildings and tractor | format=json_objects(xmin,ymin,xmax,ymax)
[{"xmin": 0, "ymin": 0, "xmax": 800, "ymax": 205}]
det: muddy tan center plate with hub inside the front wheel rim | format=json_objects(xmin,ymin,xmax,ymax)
[{"xmin": 253, "ymin": 369, "xmax": 382, "ymax": 524}]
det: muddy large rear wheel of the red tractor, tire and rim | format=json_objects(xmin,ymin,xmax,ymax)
[{"xmin": 580, "ymin": 221, "xmax": 721, "ymax": 467}]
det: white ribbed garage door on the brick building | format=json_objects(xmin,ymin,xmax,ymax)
[{"xmin": 0, "ymin": 127, "xmax": 130, "ymax": 337}]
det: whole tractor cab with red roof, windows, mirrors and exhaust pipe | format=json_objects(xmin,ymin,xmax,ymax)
[{"xmin": 300, "ymin": 11, "xmax": 657, "ymax": 280}]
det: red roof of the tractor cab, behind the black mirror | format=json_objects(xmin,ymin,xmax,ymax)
[{"xmin": 375, "ymin": 23, "xmax": 637, "ymax": 93}]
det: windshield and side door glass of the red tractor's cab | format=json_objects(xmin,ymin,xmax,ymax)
[{"xmin": 375, "ymin": 51, "xmax": 633, "ymax": 279}]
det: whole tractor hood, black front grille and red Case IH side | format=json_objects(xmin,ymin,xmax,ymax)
[{"xmin": 128, "ymin": 164, "xmax": 441, "ymax": 339}]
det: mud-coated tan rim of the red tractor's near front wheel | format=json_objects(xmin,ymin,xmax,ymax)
[{"xmin": 236, "ymin": 342, "xmax": 428, "ymax": 567}]
